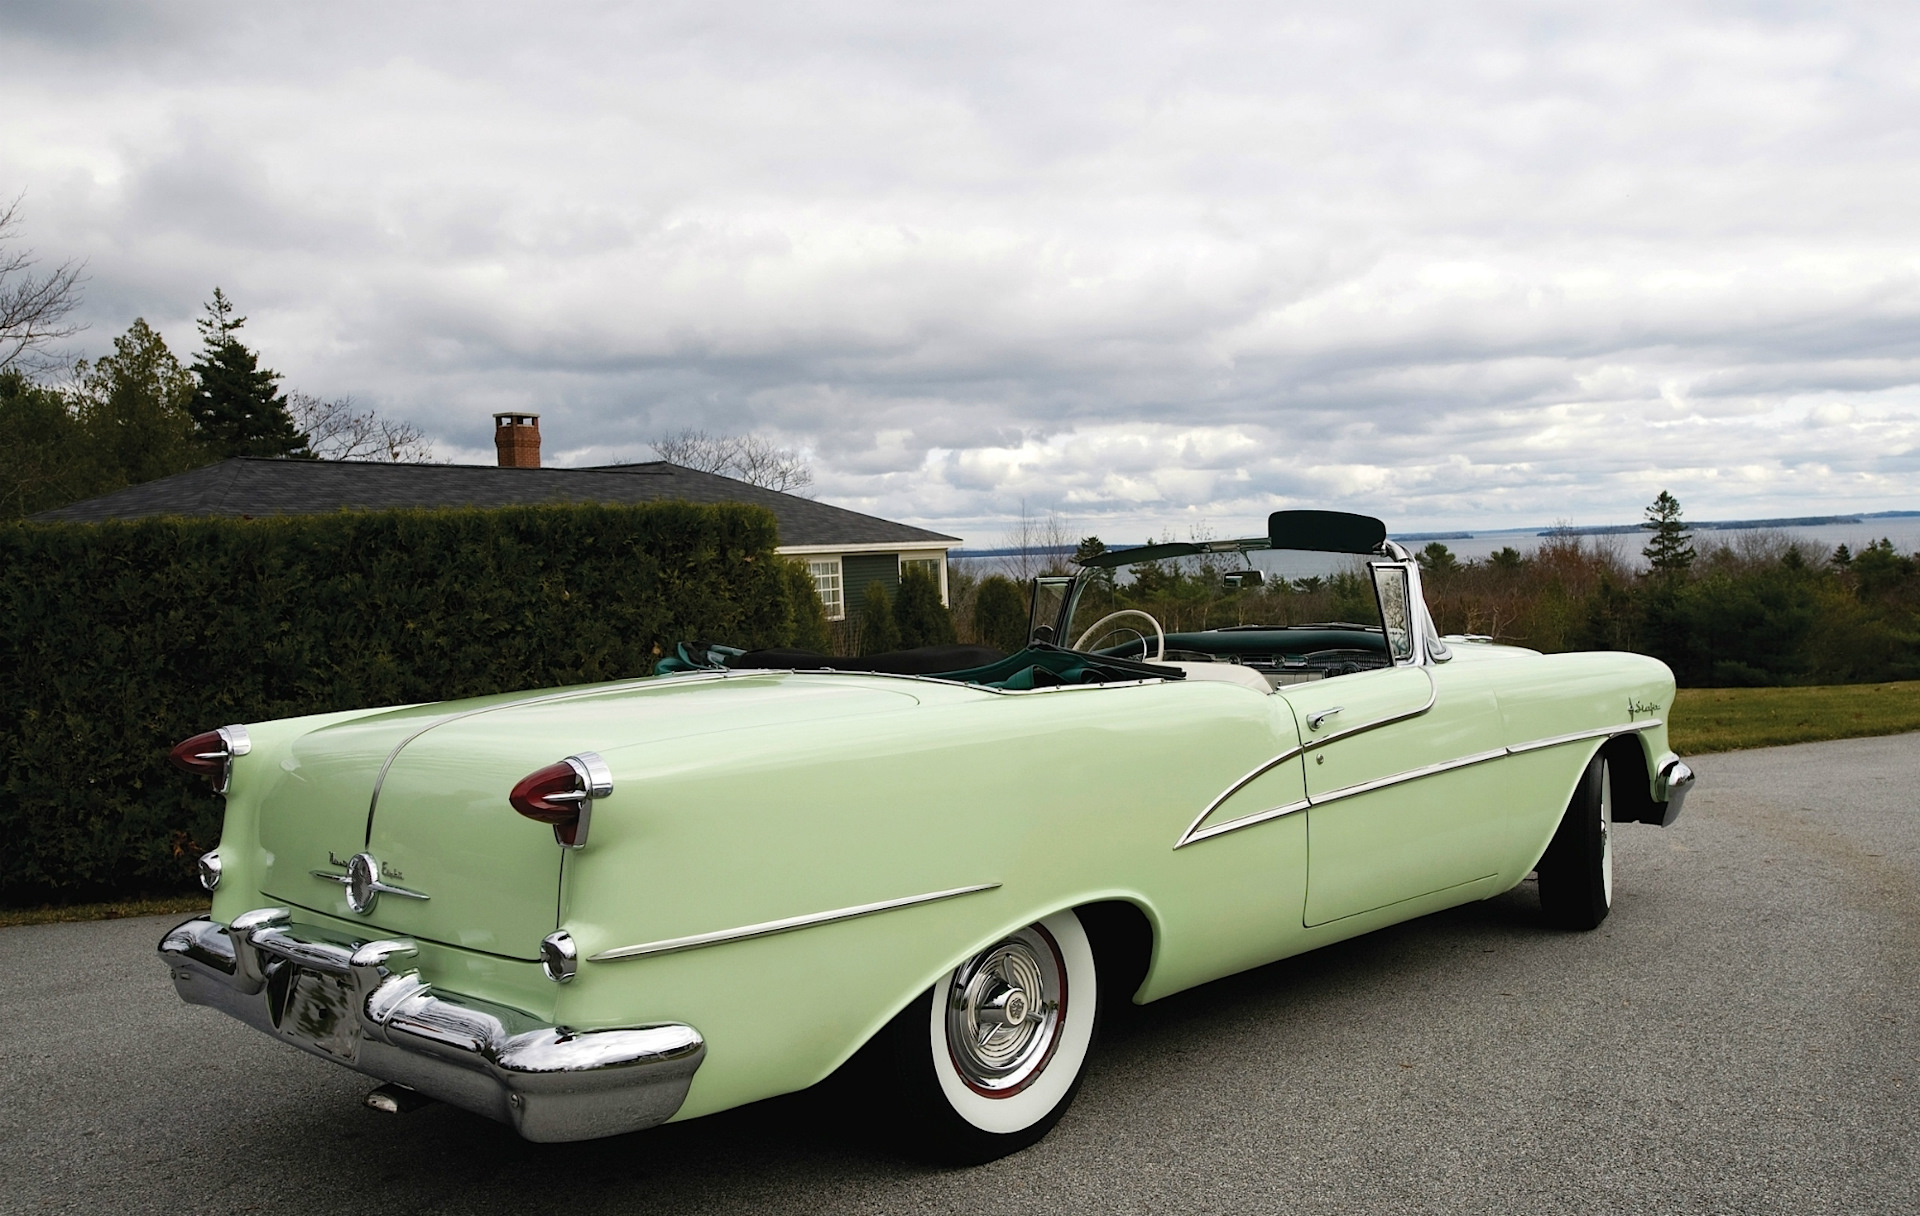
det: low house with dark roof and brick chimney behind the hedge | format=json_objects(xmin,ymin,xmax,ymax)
[{"xmin": 33, "ymin": 413, "xmax": 960, "ymax": 620}]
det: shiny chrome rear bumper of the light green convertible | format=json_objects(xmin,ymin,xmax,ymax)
[{"xmin": 159, "ymin": 909, "xmax": 707, "ymax": 1141}]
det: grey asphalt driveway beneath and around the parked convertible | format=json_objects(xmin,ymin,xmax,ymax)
[{"xmin": 0, "ymin": 736, "xmax": 1920, "ymax": 1216}]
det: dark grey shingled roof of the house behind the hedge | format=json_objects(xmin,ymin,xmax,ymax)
[{"xmin": 33, "ymin": 457, "xmax": 960, "ymax": 547}]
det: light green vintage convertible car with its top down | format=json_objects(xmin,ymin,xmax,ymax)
[{"xmin": 159, "ymin": 511, "xmax": 1693, "ymax": 1160}]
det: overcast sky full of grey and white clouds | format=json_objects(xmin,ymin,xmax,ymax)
[{"xmin": 0, "ymin": 0, "xmax": 1920, "ymax": 544}]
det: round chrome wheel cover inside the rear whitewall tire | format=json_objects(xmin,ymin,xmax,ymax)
[{"xmin": 947, "ymin": 924, "xmax": 1068, "ymax": 1097}]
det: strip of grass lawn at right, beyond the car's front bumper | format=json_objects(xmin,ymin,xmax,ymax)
[{"xmin": 1667, "ymin": 680, "xmax": 1920, "ymax": 755}]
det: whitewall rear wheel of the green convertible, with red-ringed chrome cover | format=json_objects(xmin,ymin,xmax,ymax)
[{"xmin": 883, "ymin": 911, "xmax": 1100, "ymax": 1164}]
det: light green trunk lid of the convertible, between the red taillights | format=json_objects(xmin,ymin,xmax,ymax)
[{"xmin": 261, "ymin": 674, "xmax": 918, "ymax": 959}]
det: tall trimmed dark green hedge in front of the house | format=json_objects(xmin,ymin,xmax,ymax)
[{"xmin": 0, "ymin": 503, "xmax": 822, "ymax": 907}]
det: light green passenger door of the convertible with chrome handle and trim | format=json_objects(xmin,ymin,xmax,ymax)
[{"xmin": 1281, "ymin": 564, "xmax": 1505, "ymax": 926}]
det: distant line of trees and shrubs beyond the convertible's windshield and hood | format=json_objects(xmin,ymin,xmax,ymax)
[{"xmin": 948, "ymin": 490, "xmax": 1920, "ymax": 688}]
